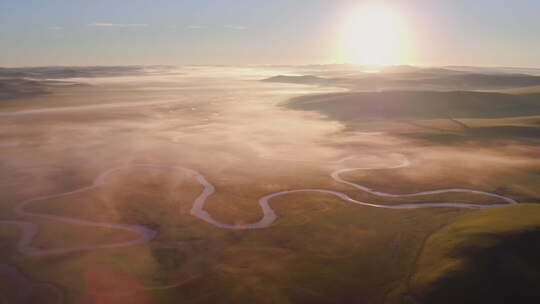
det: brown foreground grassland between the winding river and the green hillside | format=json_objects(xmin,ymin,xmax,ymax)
[{"xmin": 10, "ymin": 194, "xmax": 466, "ymax": 303}]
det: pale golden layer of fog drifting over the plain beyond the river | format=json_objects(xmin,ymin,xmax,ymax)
[{"xmin": 0, "ymin": 67, "xmax": 537, "ymax": 249}]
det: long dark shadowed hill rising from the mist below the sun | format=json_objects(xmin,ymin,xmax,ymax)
[{"xmin": 283, "ymin": 91, "xmax": 540, "ymax": 123}]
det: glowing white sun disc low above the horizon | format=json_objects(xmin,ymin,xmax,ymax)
[{"xmin": 341, "ymin": 6, "xmax": 405, "ymax": 65}]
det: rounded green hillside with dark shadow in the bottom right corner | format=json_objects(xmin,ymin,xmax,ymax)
[{"xmin": 410, "ymin": 204, "xmax": 540, "ymax": 304}]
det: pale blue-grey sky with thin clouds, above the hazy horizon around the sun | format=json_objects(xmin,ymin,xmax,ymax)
[{"xmin": 0, "ymin": 0, "xmax": 540, "ymax": 67}]
